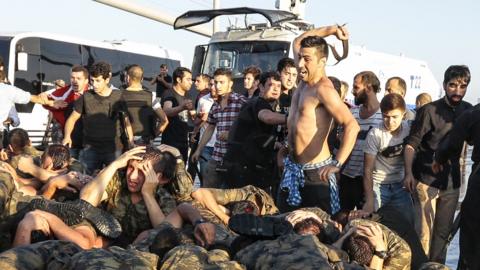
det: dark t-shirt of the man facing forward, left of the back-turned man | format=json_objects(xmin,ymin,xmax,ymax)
[{"xmin": 74, "ymin": 90, "xmax": 127, "ymax": 152}]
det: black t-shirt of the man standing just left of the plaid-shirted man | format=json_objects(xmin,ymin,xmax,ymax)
[{"xmin": 162, "ymin": 89, "xmax": 189, "ymax": 146}]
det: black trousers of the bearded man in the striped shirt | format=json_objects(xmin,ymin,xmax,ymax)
[{"xmin": 339, "ymin": 174, "xmax": 364, "ymax": 210}]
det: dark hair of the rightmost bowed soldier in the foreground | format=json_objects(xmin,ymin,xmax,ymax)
[{"xmin": 342, "ymin": 235, "xmax": 375, "ymax": 265}]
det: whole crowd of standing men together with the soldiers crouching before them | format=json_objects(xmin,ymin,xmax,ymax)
[{"xmin": 0, "ymin": 26, "xmax": 480, "ymax": 269}]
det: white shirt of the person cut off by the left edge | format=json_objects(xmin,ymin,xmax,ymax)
[{"xmin": 0, "ymin": 83, "xmax": 31, "ymax": 130}]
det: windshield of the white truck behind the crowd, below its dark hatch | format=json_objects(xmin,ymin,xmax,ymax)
[{"xmin": 203, "ymin": 41, "xmax": 290, "ymax": 77}]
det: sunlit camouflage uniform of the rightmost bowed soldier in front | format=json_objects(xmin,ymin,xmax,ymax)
[{"xmin": 350, "ymin": 219, "xmax": 412, "ymax": 270}]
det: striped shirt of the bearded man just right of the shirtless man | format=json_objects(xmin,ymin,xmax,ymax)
[{"xmin": 342, "ymin": 106, "xmax": 383, "ymax": 178}]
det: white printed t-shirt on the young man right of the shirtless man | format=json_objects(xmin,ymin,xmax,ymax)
[{"xmin": 364, "ymin": 121, "xmax": 410, "ymax": 184}]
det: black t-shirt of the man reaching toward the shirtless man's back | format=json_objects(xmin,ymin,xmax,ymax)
[{"xmin": 227, "ymin": 97, "xmax": 277, "ymax": 164}]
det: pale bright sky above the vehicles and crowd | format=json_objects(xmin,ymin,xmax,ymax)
[{"xmin": 0, "ymin": 0, "xmax": 480, "ymax": 104}]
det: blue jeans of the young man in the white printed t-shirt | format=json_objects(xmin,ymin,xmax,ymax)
[{"xmin": 373, "ymin": 182, "xmax": 414, "ymax": 224}]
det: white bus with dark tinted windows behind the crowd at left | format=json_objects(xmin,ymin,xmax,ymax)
[{"xmin": 0, "ymin": 32, "xmax": 183, "ymax": 145}]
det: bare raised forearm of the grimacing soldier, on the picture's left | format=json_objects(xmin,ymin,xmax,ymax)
[{"xmin": 80, "ymin": 146, "xmax": 146, "ymax": 207}]
